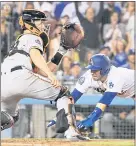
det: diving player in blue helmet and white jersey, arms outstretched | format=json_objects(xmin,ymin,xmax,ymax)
[{"xmin": 49, "ymin": 54, "xmax": 135, "ymax": 131}]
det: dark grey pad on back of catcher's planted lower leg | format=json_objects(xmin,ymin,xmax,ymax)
[{"xmin": 56, "ymin": 108, "xmax": 69, "ymax": 133}]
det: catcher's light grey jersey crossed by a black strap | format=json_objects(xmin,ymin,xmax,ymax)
[{"xmin": 2, "ymin": 34, "xmax": 43, "ymax": 71}]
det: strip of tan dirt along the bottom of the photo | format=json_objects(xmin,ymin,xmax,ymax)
[{"xmin": 1, "ymin": 139, "xmax": 134, "ymax": 146}]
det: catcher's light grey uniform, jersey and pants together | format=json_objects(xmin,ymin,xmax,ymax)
[{"xmin": 1, "ymin": 34, "xmax": 60, "ymax": 116}]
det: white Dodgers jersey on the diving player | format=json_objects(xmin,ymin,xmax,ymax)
[{"xmin": 75, "ymin": 66, "xmax": 134, "ymax": 98}]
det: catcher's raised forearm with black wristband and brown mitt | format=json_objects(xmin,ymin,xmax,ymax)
[{"xmin": 48, "ymin": 23, "xmax": 84, "ymax": 71}]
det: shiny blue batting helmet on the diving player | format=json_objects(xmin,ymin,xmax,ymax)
[{"xmin": 86, "ymin": 54, "xmax": 111, "ymax": 76}]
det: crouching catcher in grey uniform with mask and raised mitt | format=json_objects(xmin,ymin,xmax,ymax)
[{"xmin": 1, "ymin": 9, "xmax": 84, "ymax": 139}]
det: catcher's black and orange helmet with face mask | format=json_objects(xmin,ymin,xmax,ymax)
[{"xmin": 19, "ymin": 9, "xmax": 50, "ymax": 47}]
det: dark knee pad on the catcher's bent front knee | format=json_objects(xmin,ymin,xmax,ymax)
[{"xmin": 55, "ymin": 86, "xmax": 70, "ymax": 101}]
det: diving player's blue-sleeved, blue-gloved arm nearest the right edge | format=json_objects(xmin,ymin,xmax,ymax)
[{"xmin": 77, "ymin": 92, "xmax": 117, "ymax": 129}]
